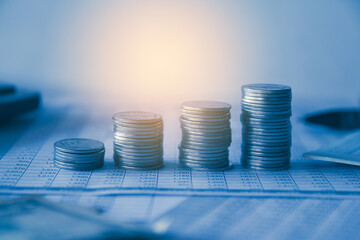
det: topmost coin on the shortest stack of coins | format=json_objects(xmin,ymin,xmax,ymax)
[{"xmin": 54, "ymin": 138, "xmax": 105, "ymax": 153}]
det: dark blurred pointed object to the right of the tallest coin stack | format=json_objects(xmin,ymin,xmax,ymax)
[{"xmin": 305, "ymin": 108, "xmax": 360, "ymax": 130}]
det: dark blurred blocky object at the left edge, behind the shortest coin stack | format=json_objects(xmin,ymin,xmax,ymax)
[{"xmin": 0, "ymin": 83, "xmax": 40, "ymax": 121}]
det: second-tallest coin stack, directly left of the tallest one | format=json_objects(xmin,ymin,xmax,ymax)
[{"xmin": 179, "ymin": 101, "xmax": 231, "ymax": 170}]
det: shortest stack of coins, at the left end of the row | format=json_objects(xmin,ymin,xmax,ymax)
[{"xmin": 54, "ymin": 138, "xmax": 105, "ymax": 170}]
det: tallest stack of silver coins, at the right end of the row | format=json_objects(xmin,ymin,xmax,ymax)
[{"xmin": 241, "ymin": 84, "xmax": 292, "ymax": 170}]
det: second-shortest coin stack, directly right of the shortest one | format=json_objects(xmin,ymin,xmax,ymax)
[{"xmin": 113, "ymin": 112, "xmax": 164, "ymax": 170}]
